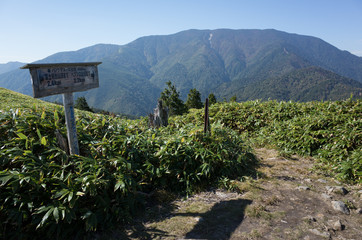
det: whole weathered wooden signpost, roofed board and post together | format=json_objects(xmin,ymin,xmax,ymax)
[{"xmin": 21, "ymin": 62, "xmax": 101, "ymax": 155}]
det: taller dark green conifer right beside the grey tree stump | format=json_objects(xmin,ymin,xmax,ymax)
[{"xmin": 160, "ymin": 81, "xmax": 187, "ymax": 116}]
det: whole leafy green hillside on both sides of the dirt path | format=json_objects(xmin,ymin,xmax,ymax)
[{"xmin": 0, "ymin": 89, "xmax": 362, "ymax": 239}]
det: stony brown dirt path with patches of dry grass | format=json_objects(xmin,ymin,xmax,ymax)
[{"xmin": 114, "ymin": 148, "xmax": 362, "ymax": 240}]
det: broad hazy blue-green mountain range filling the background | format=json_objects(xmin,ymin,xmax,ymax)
[{"xmin": 0, "ymin": 29, "xmax": 362, "ymax": 115}]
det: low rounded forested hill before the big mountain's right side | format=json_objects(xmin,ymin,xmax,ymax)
[{"xmin": 236, "ymin": 67, "xmax": 362, "ymax": 102}]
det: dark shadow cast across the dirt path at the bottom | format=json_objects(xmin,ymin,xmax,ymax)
[{"xmin": 184, "ymin": 199, "xmax": 252, "ymax": 240}]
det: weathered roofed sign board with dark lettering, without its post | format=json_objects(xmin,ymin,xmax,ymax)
[{"xmin": 22, "ymin": 62, "xmax": 101, "ymax": 98}]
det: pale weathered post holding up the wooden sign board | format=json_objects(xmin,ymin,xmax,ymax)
[{"xmin": 63, "ymin": 93, "xmax": 79, "ymax": 155}]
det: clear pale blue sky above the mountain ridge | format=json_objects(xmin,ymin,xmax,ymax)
[{"xmin": 0, "ymin": 0, "xmax": 362, "ymax": 63}]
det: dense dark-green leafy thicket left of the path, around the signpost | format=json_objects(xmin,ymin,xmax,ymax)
[{"xmin": 0, "ymin": 102, "xmax": 256, "ymax": 239}]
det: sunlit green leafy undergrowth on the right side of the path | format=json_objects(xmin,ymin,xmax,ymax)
[{"xmin": 182, "ymin": 100, "xmax": 362, "ymax": 183}]
